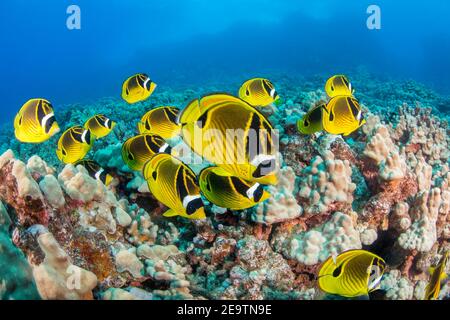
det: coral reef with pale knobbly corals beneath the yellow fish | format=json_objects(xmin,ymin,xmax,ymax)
[{"xmin": 0, "ymin": 72, "xmax": 450, "ymax": 300}]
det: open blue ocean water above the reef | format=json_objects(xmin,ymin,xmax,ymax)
[{"xmin": 0, "ymin": 0, "xmax": 450, "ymax": 123}]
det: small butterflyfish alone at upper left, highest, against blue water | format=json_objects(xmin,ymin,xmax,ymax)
[{"xmin": 122, "ymin": 73, "xmax": 156, "ymax": 104}]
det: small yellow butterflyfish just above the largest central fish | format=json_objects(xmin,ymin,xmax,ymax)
[{"xmin": 239, "ymin": 78, "xmax": 280, "ymax": 107}]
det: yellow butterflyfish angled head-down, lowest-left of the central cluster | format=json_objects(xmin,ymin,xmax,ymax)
[{"xmin": 143, "ymin": 153, "xmax": 206, "ymax": 220}]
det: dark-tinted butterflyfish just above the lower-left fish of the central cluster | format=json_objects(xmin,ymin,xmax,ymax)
[{"xmin": 122, "ymin": 133, "xmax": 171, "ymax": 171}]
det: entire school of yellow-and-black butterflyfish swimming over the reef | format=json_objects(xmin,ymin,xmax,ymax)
[{"xmin": 14, "ymin": 73, "xmax": 448, "ymax": 299}]
